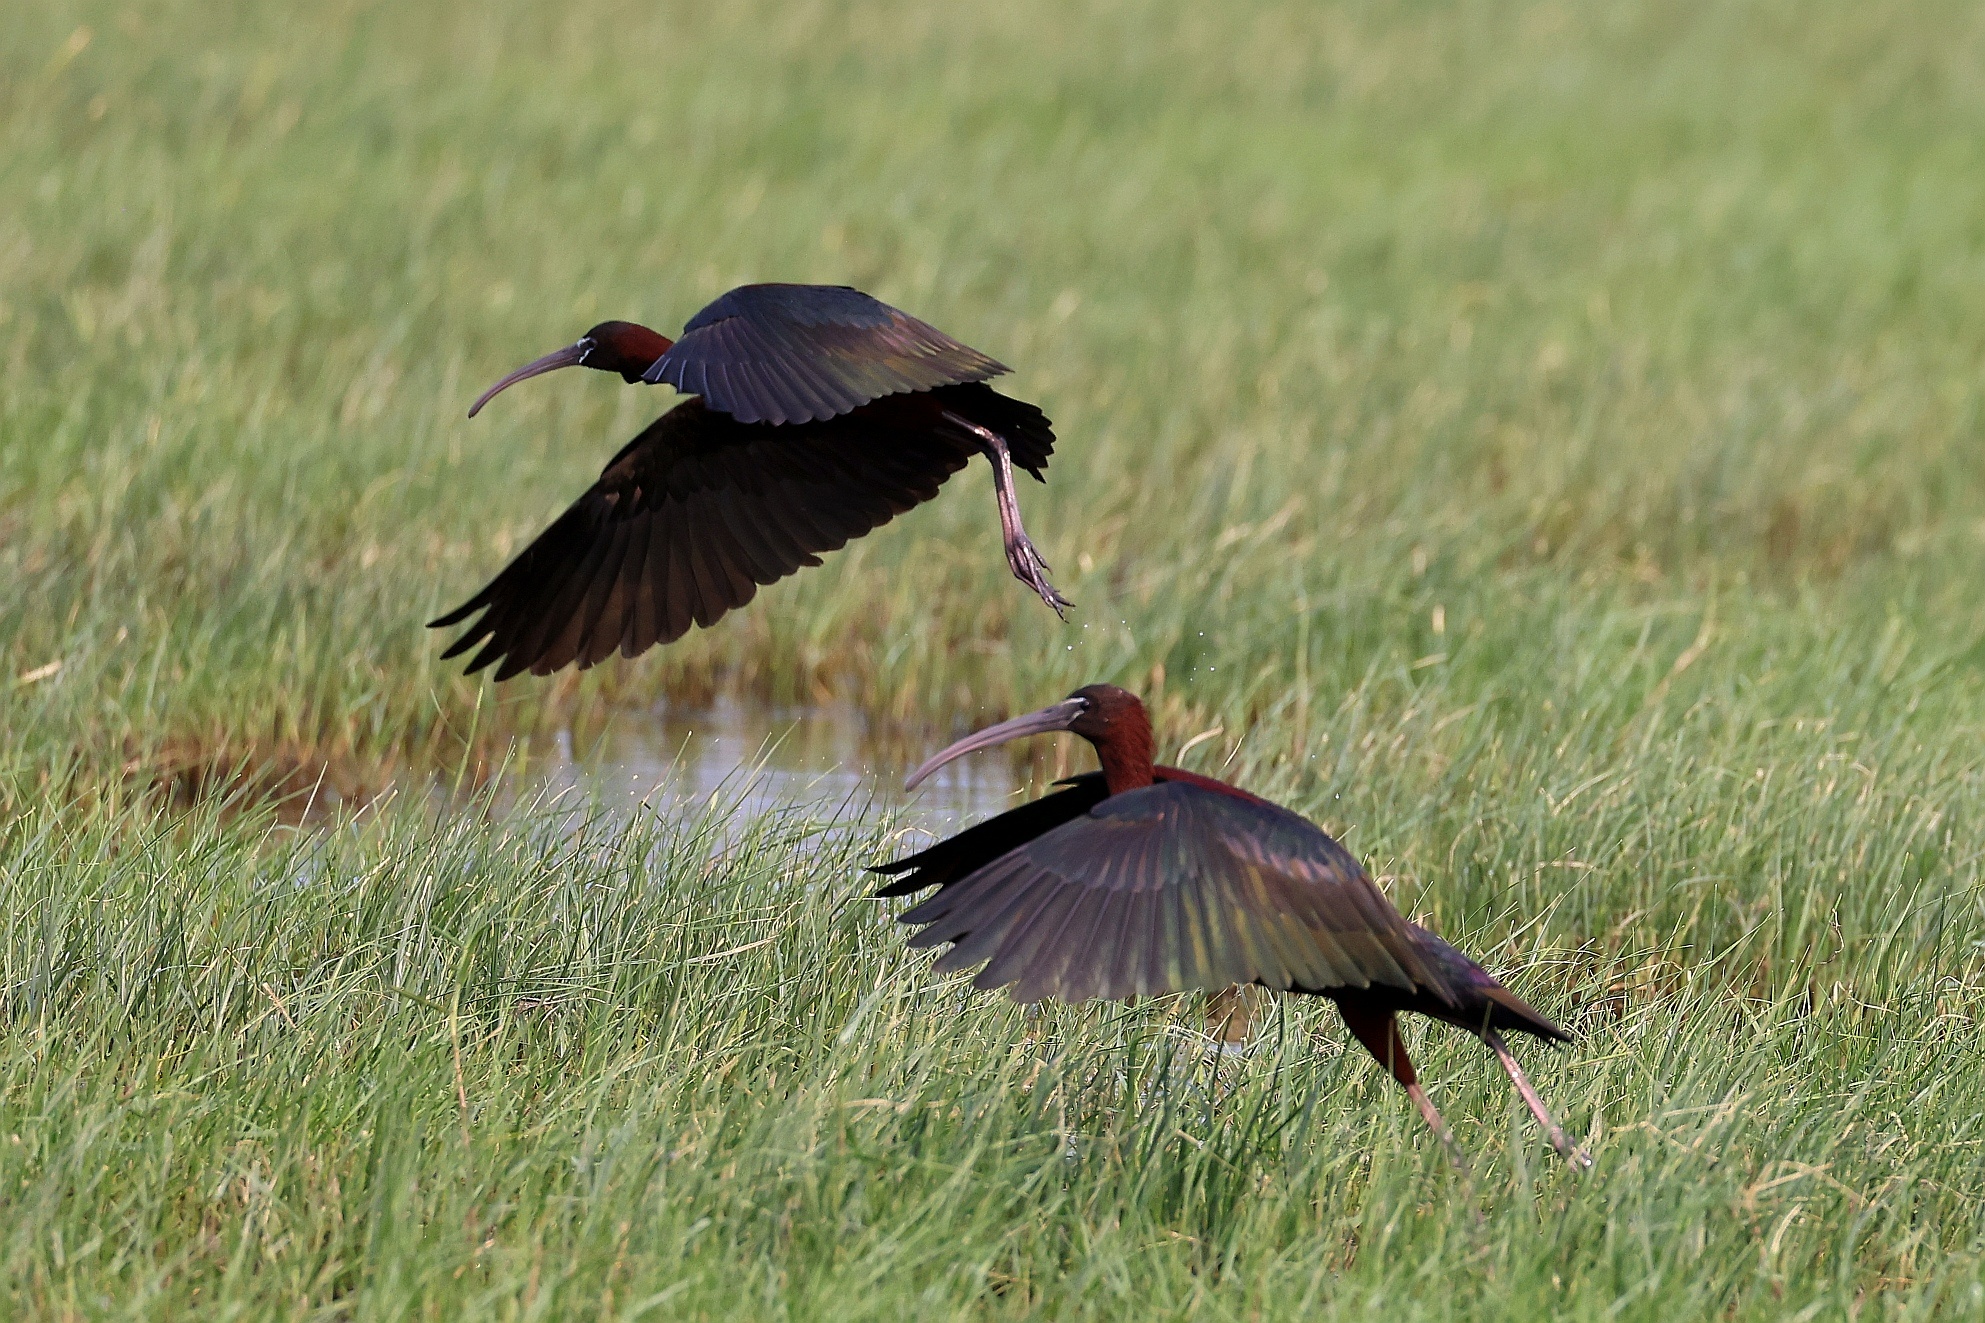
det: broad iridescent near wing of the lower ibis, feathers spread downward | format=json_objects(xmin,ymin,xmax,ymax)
[{"xmin": 901, "ymin": 783, "xmax": 1453, "ymax": 1003}]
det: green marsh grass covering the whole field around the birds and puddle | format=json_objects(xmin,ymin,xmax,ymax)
[{"xmin": 0, "ymin": 0, "xmax": 1985, "ymax": 1319}]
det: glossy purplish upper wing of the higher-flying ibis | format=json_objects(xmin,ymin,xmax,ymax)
[{"xmin": 645, "ymin": 284, "xmax": 1006, "ymax": 423}]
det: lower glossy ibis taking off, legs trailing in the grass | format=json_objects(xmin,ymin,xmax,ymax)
[{"xmin": 871, "ymin": 685, "xmax": 1592, "ymax": 1166}]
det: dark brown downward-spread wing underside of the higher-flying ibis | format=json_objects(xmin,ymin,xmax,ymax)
[{"xmin": 433, "ymin": 399, "xmax": 973, "ymax": 679}]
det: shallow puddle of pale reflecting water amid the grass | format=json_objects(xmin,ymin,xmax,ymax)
[{"xmin": 520, "ymin": 699, "xmax": 1014, "ymax": 834}]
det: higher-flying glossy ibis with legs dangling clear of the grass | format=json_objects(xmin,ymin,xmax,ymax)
[{"xmin": 433, "ymin": 284, "xmax": 1068, "ymax": 679}]
